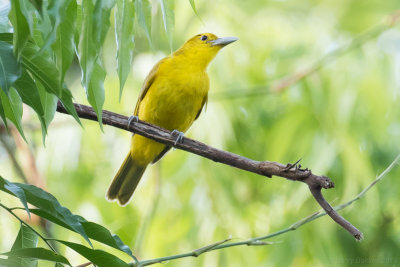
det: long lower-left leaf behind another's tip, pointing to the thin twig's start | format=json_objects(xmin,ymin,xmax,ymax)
[{"xmin": 30, "ymin": 209, "xmax": 135, "ymax": 259}]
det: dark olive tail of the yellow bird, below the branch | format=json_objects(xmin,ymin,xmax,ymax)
[{"xmin": 107, "ymin": 153, "xmax": 147, "ymax": 205}]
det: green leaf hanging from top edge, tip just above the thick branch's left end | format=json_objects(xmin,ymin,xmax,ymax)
[{"xmin": 52, "ymin": 1, "xmax": 77, "ymax": 83}]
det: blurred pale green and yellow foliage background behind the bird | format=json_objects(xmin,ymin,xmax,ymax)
[{"xmin": 0, "ymin": 0, "xmax": 400, "ymax": 267}]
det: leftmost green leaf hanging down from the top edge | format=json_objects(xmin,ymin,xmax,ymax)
[{"xmin": 8, "ymin": 0, "xmax": 30, "ymax": 59}]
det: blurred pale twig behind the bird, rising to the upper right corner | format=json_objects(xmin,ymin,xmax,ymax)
[{"xmin": 210, "ymin": 10, "xmax": 400, "ymax": 100}]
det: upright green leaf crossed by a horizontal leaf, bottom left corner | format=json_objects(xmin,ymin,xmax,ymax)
[{"xmin": 8, "ymin": 224, "xmax": 38, "ymax": 267}]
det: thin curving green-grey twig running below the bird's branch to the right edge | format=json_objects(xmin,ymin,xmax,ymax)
[{"xmin": 133, "ymin": 154, "xmax": 400, "ymax": 267}]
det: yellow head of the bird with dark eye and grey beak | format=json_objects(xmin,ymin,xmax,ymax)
[{"xmin": 173, "ymin": 33, "xmax": 238, "ymax": 68}]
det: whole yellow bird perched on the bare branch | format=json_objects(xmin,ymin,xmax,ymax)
[{"xmin": 107, "ymin": 33, "xmax": 238, "ymax": 205}]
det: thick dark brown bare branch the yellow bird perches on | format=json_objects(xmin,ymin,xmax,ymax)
[{"xmin": 57, "ymin": 102, "xmax": 362, "ymax": 240}]
